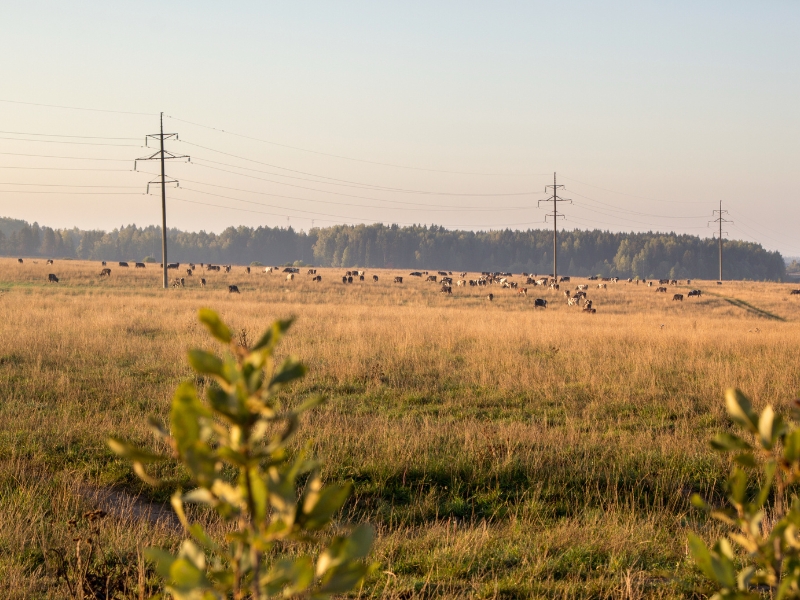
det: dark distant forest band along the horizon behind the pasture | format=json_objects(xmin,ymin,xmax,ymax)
[{"xmin": 0, "ymin": 218, "xmax": 786, "ymax": 281}]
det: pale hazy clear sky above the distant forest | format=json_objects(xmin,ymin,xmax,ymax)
[{"xmin": 0, "ymin": 0, "xmax": 800, "ymax": 256}]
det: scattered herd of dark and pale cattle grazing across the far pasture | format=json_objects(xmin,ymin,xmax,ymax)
[{"xmin": 10, "ymin": 258, "xmax": 800, "ymax": 314}]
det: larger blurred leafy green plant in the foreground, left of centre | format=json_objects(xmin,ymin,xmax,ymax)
[{"xmin": 109, "ymin": 309, "xmax": 374, "ymax": 600}]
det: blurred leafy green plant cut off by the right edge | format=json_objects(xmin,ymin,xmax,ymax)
[{"xmin": 689, "ymin": 390, "xmax": 800, "ymax": 600}]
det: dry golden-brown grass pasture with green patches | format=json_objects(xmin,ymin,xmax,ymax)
[{"xmin": 0, "ymin": 259, "xmax": 800, "ymax": 599}]
